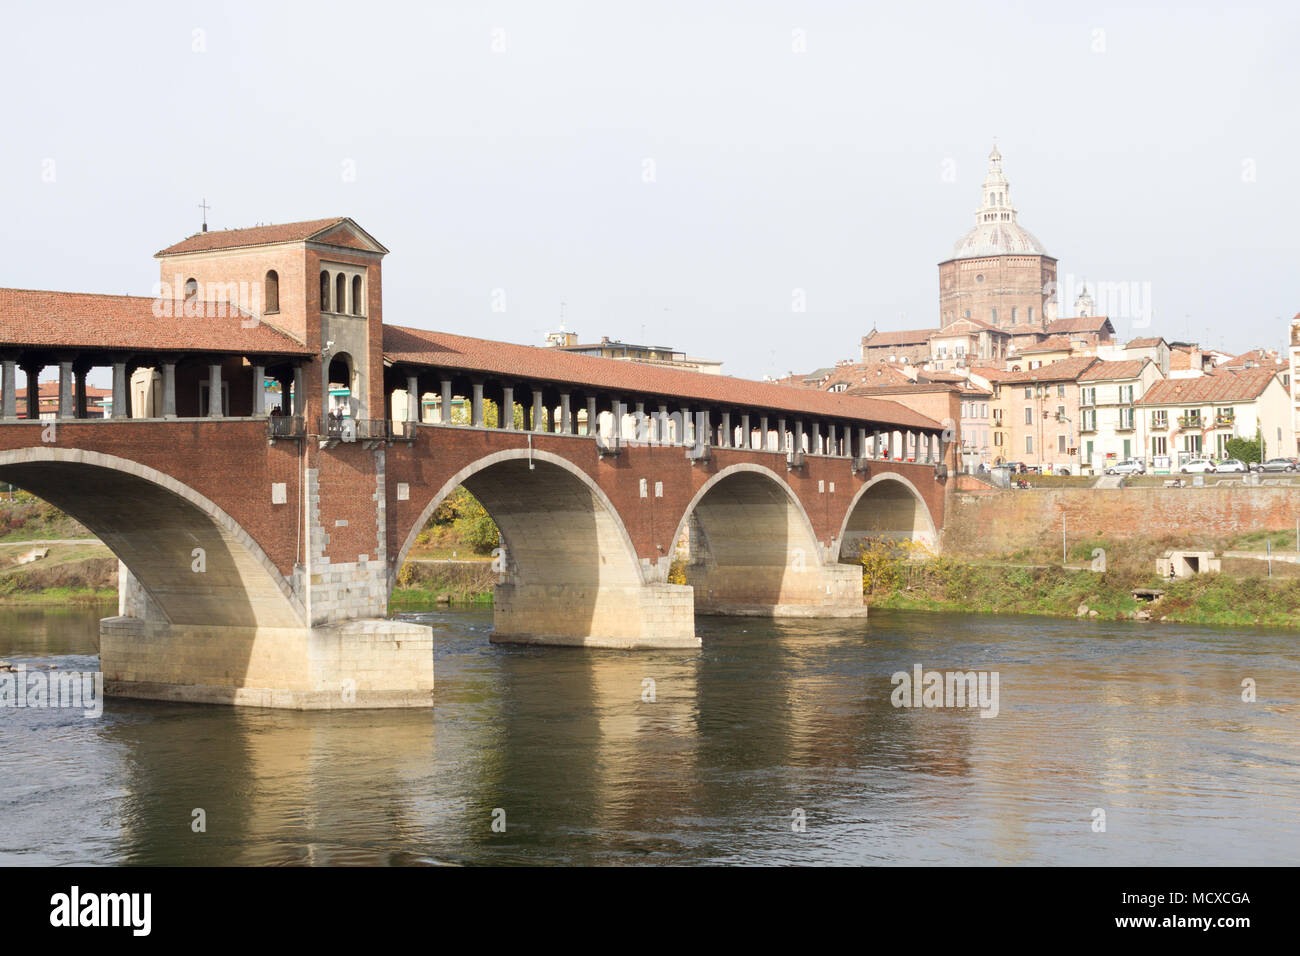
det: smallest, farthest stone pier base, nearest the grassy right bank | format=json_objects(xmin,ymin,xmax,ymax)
[{"xmin": 686, "ymin": 564, "xmax": 867, "ymax": 618}]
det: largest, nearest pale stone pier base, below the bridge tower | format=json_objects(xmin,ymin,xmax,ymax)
[{"xmin": 99, "ymin": 617, "xmax": 433, "ymax": 710}]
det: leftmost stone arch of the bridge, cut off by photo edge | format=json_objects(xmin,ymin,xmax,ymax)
[{"xmin": 0, "ymin": 447, "xmax": 306, "ymax": 627}]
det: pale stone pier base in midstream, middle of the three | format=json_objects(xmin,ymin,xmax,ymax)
[{"xmin": 491, "ymin": 584, "xmax": 699, "ymax": 650}]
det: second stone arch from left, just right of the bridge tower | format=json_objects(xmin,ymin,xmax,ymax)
[{"xmin": 389, "ymin": 449, "xmax": 645, "ymax": 593}]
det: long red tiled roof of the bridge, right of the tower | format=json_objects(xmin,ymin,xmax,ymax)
[{"xmin": 384, "ymin": 325, "xmax": 940, "ymax": 428}]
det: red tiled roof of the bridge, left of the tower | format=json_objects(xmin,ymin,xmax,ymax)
[{"xmin": 0, "ymin": 289, "xmax": 312, "ymax": 355}]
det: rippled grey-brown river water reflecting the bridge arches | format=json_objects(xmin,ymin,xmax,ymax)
[{"xmin": 0, "ymin": 609, "xmax": 1300, "ymax": 865}]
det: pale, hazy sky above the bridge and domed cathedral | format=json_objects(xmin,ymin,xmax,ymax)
[{"xmin": 0, "ymin": 0, "xmax": 1300, "ymax": 377}]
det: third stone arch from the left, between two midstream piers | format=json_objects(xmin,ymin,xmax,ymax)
[{"xmin": 673, "ymin": 463, "xmax": 824, "ymax": 613}]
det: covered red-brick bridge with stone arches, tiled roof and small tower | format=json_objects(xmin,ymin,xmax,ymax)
[{"xmin": 0, "ymin": 219, "xmax": 952, "ymax": 708}]
